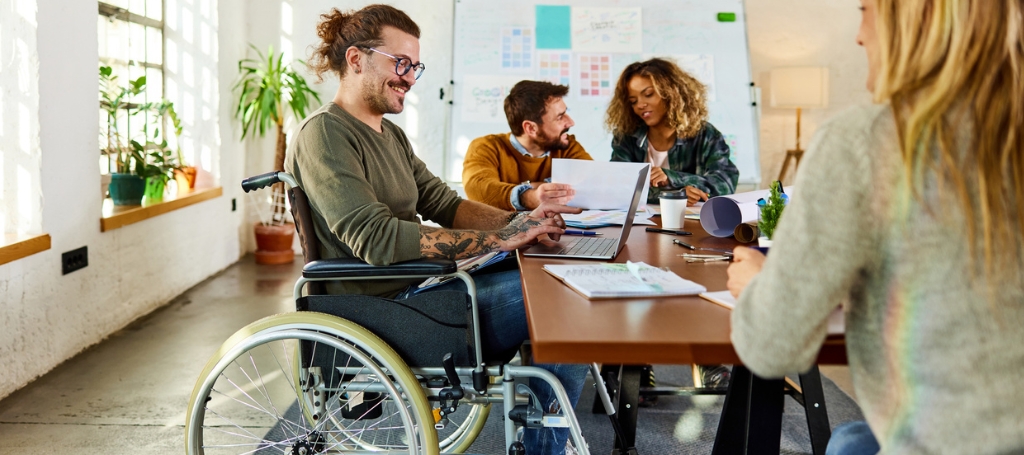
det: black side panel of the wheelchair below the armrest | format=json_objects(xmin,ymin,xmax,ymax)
[{"xmin": 297, "ymin": 291, "xmax": 475, "ymax": 367}]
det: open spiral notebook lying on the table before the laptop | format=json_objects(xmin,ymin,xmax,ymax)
[{"xmin": 544, "ymin": 262, "xmax": 708, "ymax": 299}]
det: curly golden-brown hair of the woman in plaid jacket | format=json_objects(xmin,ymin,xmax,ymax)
[{"xmin": 604, "ymin": 58, "xmax": 708, "ymax": 139}]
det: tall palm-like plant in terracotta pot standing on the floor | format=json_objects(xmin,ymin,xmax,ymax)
[{"xmin": 233, "ymin": 45, "xmax": 321, "ymax": 263}]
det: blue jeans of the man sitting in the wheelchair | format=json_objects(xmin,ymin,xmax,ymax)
[{"xmin": 396, "ymin": 270, "xmax": 590, "ymax": 455}]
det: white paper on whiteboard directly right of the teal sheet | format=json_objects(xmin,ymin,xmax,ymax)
[{"xmin": 571, "ymin": 7, "xmax": 643, "ymax": 53}]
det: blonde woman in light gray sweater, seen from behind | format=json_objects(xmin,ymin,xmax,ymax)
[{"xmin": 729, "ymin": 0, "xmax": 1024, "ymax": 454}]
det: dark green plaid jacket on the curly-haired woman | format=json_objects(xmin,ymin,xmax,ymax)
[{"xmin": 611, "ymin": 122, "xmax": 739, "ymax": 204}]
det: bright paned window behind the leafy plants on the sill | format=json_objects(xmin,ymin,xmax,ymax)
[{"xmin": 97, "ymin": 0, "xmax": 165, "ymax": 174}]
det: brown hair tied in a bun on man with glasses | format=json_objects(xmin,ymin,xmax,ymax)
[{"xmin": 309, "ymin": 4, "xmax": 420, "ymax": 81}]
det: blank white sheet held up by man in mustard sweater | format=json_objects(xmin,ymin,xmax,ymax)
[{"xmin": 551, "ymin": 159, "xmax": 650, "ymax": 210}]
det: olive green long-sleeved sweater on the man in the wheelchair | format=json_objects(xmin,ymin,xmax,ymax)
[{"xmin": 285, "ymin": 102, "xmax": 462, "ymax": 296}]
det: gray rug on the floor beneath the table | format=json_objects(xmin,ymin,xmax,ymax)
[{"xmin": 469, "ymin": 365, "xmax": 863, "ymax": 455}]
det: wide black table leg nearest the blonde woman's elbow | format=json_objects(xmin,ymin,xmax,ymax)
[{"xmin": 712, "ymin": 365, "xmax": 784, "ymax": 455}]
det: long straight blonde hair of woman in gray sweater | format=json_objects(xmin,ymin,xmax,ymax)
[{"xmin": 874, "ymin": 0, "xmax": 1024, "ymax": 277}]
